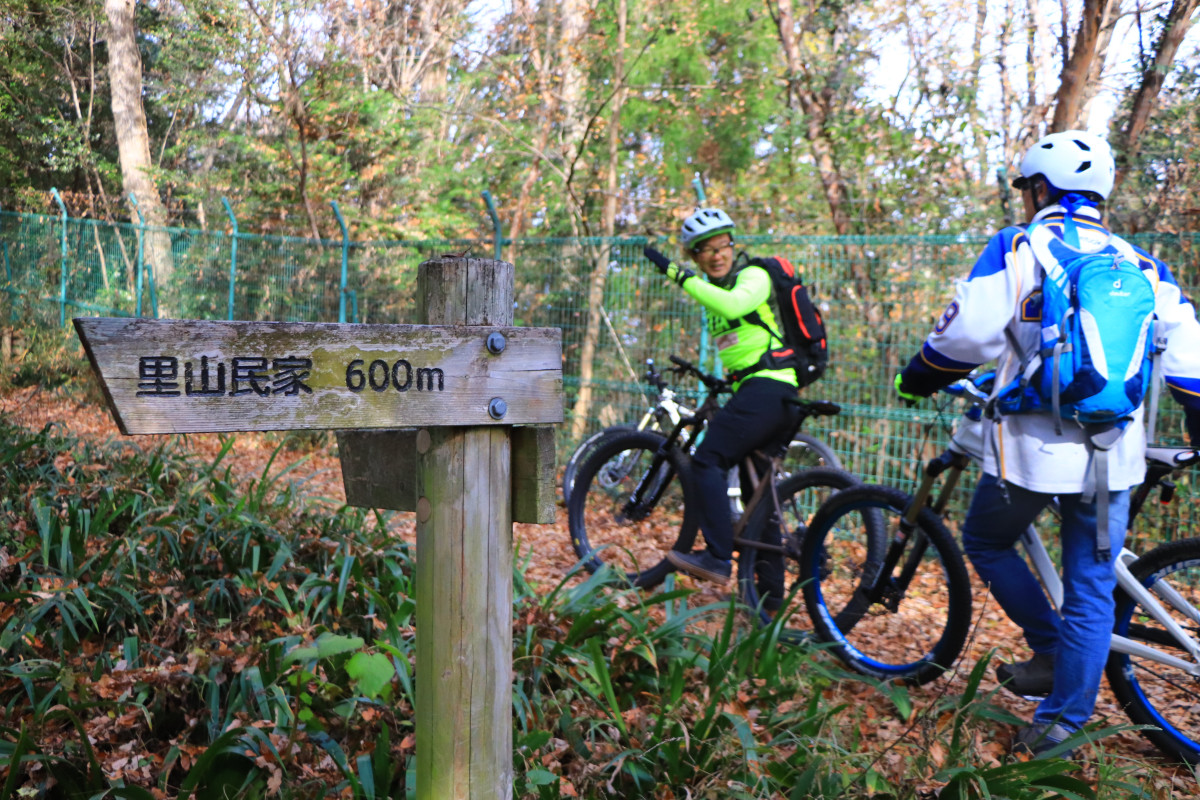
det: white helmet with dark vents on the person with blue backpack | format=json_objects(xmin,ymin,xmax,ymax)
[{"xmin": 1013, "ymin": 131, "xmax": 1117, "ymax": 199}]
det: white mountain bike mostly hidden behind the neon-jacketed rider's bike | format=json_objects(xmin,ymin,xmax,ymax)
[{"xmin": 562, "ymin": 359, "xmax": 841, "ymax": 504}]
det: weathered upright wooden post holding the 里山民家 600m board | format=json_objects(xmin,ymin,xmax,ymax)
[{"xmin": 415, "ymin": 257, "xmax": 514, "ymax": 800}]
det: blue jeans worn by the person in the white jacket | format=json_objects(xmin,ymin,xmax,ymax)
[{"xmin": 962, "ymin": 475, "xmax": 1129, "ymax": 730}]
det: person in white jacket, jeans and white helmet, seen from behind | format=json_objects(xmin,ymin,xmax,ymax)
[{"xmin": 895, "ymin": 131, "xmax": 1200, "ymax": 754}]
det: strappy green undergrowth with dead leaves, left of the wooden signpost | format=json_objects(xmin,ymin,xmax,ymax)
[{"xmin": 0, "ymin": 426, "xmax": 422, "ymax": 798}]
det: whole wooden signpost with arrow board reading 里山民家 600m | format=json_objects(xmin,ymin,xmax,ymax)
[{"xmin": 74, "ymin": 255, "xmax": 563, "ymax": 800}]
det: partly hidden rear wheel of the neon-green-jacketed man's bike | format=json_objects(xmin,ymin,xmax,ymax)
[{"xmin": 738, "ymin": 467, "xmax": 873, "ymax": 639}]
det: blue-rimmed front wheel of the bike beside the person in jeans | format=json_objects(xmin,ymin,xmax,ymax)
[{"xmin": 800, "ymin": 486, "xmax": 971, "ymax": 684}]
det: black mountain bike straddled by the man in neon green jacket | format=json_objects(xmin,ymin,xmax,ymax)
[{"xmin": 568, "ymin": 356, "xmax": 868, "ymax": 594}]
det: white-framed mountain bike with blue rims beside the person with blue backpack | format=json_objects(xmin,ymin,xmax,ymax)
[{"xmin": 800, "ymin": 383, "xmax": 1200, "ymax": 764}]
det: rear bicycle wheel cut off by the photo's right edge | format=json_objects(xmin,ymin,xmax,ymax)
[{"xmin": 1105, "ymin": 539, "xmax": 1200, "ymax": 764}]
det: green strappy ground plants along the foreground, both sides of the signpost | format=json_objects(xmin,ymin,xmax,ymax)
[{"xmin": 0, "ymin": 422, "xmax": 1185, "ymax": 800}]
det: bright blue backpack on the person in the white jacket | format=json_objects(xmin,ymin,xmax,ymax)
[{"xmin": 996, "ymin": 223, "xmax": 1154, "ymax": 438}]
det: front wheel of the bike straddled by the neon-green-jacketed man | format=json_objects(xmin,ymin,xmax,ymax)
[{"xmin": 568, "ymin": 431, "xmax": 700, "ymax": 587}]
